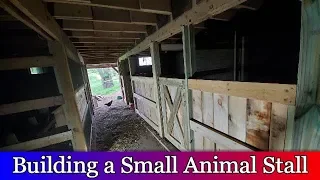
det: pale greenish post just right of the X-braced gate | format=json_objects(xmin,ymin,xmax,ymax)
[{"xmin": 182, "ymin": 25, "xmax": 196, "ymax": 150}]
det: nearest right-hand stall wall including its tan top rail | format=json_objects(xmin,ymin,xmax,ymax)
[{"xmin": 189, "ymin": 80, "xmax": 296, "ymax": 151}]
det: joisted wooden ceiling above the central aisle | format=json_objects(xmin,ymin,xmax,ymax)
[{"xmin": 43, "ymin": 0, "xmax": 172, "ymax": 64}]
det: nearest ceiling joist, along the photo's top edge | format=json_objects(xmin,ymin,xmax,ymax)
[{"xmin": 44, "ymin": 0, "xmax": 171, "ymax": 15}]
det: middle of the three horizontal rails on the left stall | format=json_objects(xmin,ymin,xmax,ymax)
[{"xmin": 0, "ymin": 96, "xmax": 64, "ymax": 115}]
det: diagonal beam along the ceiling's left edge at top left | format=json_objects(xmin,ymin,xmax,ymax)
[{"xmin": 10, "ymin": 0, "xmax": 80, "ymax": 62}]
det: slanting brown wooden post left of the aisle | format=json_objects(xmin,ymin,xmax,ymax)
[{"xmin": 49, "ymin": 41, "xmax": 87, "ymax": 151}]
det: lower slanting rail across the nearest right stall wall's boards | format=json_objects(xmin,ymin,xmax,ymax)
[{"xmin": 190, "ymin": 120, "xmax": 258, "ymax": 151}]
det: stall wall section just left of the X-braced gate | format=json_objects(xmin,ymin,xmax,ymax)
[{"xmin": 131, "ymin": 76, "xmax": 159, "ymax": 131}]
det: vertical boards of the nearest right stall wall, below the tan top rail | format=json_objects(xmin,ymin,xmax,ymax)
[{"xmin": 192, "ymin": 79, "xmax": 294, "ymax": 151}]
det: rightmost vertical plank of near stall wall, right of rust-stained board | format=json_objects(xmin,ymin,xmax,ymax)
[{"xmin": 269, "ymin": 103, "xmax": 288, "ymax": 151}]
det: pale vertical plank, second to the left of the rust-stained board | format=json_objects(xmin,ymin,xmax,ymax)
[{"xmin": 213, "ymin": 94, "xmax": 229, "ymax": 134}]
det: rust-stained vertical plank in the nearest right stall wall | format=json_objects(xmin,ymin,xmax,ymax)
[{"xmin": 246, "ymin": 99, "xmax": 272, "ymax": 150}]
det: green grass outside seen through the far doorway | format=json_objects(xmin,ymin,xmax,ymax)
[{"xmin": 88, "ymin": 69, "xmax": 120, "ymax": 95}]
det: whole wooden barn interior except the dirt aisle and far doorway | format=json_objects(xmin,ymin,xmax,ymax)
[{"xmin": 0, "ymin": 0, "xmax": 320, "ymax": 151}]
